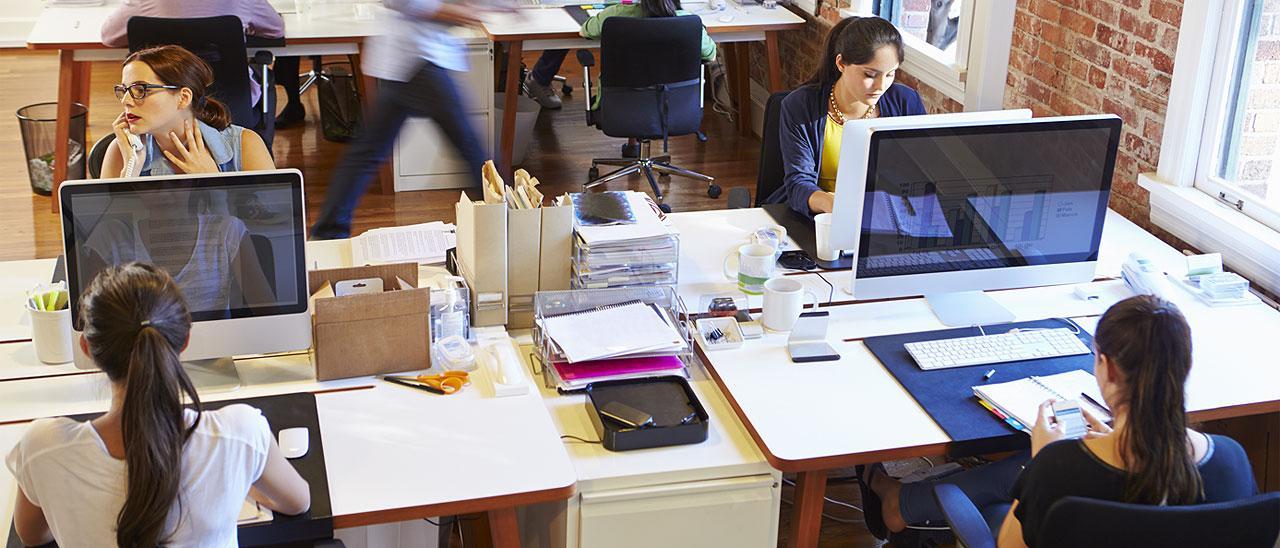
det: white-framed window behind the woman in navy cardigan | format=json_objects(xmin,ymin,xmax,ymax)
[{"xmin": 841, "ymin": 0, "xmax": 1015, "ymax": 110}]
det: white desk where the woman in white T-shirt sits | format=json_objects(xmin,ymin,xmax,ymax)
[{"xmin": 0, "ymin": 248, "xmax": 576, "ymax": 545}]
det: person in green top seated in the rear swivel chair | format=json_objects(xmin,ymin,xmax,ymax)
[{"xmin": 525, "ymin": 0, "xmax": 716, "ymax": 110}]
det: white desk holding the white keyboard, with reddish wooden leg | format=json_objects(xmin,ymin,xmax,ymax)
[{"xmin": 677, "ymin": 210, "xmax": 1280, "ymax": 547}]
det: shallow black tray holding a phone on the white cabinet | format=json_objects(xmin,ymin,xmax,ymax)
[{"xmin": 586, "ymin": 375, "xmax": 709, "ymax": 451}]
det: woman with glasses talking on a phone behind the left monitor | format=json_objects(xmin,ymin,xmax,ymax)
[{"xmin": 102, "ymin": 46, "xmax": 275, "ymax": 177}]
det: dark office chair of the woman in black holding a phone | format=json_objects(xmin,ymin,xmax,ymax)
[{"xmin": 933, "ymin": 484, "xmax": 1280, "ymax": 548}]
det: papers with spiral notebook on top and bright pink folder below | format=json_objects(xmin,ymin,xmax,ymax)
[{"xmin": 539, "ymin": 301, "xmax": 689, "ymax": 391}]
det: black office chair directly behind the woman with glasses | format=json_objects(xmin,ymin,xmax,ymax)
[{"xmin": 128, "ymin": 15, "xmax": 277, "ymax": 150}]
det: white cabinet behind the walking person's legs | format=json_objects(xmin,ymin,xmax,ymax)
[{"xmin": 394, "ymin": 35, "xmax": 494, "ymax": 192}]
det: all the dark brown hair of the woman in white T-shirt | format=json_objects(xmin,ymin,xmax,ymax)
[{"xmin": 81, "ymin": 262, "xmax": 200, "ymax": 547}]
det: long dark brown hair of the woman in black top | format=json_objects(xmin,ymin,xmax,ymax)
[{"xmin": 1093, "ymin": 296, "xmax": 1203, "ymax": 504}]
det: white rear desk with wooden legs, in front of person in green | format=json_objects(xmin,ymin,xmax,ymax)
[{"xmin": 484, "ymin": 3, "xmax": 804, "ymax": 179}]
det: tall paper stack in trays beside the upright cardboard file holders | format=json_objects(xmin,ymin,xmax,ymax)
[{"xmin": 567, "ymin": 191, "xmax": 680, "ymax": 289}]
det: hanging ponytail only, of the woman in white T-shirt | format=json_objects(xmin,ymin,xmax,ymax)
[{"xmin": 115, "ymin": 325, "xmax": 200, "ymax": 547}]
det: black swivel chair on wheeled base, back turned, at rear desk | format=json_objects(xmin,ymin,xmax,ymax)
[{"xmin": 577, "ymin": 15, "xmax": 721, "ymax": 211}]
